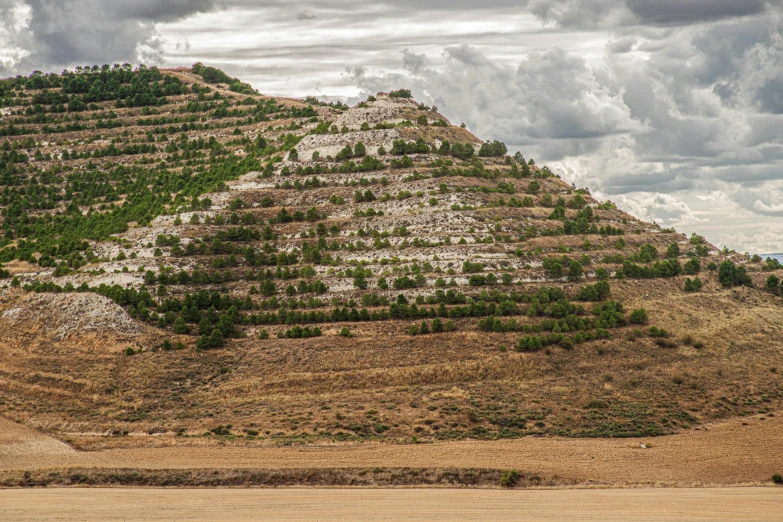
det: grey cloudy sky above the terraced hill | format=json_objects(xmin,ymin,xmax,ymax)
[{"xmin": 0, "ymin": 0, "xmax": 783, "ymax": 253}]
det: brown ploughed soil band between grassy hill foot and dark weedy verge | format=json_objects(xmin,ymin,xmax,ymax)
[{"xmin": 0, "ymin": 415, "xmax": 783, "ymax": 486}]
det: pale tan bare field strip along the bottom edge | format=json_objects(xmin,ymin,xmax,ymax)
[{"xmin": 0, "ymin": 488, "xmax": 783, "ymax": 522}]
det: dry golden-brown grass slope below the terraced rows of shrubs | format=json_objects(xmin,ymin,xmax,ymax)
[{"xmin": 0, "ymin": 280, "xmax": 783, "ymax": 447}]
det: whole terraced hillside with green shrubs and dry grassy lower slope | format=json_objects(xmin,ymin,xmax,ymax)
[{"xmin": 0, "ymin": 64, "xmax": 783, "ymax": 449}]
